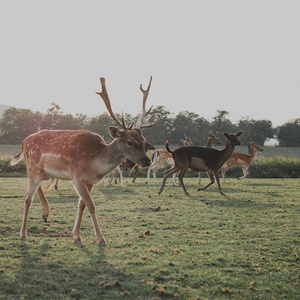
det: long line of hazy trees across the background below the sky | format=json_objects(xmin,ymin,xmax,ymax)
[{"xmin": 0, "ymin": 103, "xmax": 300, "ymax": 147}]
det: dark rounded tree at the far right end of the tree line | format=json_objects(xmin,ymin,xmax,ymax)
[{"xmin": 277, "ymin": 119, "xmax": 300, "ymax": 147}]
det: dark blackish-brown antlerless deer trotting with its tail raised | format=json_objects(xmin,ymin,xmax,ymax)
[{"xmin": 158, "ymin": 131, "xmax": 243, "ymax": 196}]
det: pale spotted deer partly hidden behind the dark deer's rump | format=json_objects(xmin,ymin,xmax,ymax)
[{"xmin": 146, "ymin": 136, "xmax": 193, "ymax": 186}]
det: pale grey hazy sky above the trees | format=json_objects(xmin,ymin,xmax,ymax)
[{"xmin": 0, "ymin": 0, "xmax": 300, "ymax": 126}]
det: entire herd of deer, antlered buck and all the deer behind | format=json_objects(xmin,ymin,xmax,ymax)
[{"xmin": 11, "ymin": 77, "xmax": 263, "ymax": 244}]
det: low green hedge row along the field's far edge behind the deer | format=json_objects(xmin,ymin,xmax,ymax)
[{"xmin": 0, "ymin": 156, "xmax": 300, "ymax": 178}]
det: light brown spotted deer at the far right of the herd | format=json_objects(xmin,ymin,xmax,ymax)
[{"xmin": 221, "ymin": 142, "xmax": 263, "ymax": 182}]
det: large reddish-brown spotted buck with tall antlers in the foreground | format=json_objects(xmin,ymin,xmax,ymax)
[{"xmin": 11, "ymin": 77, "xmax": 154, "ymax": 245}]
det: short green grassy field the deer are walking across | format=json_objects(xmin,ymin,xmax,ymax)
[{"xmin": 0, "ymin": 178, "xmax": 300, "ymax": 299}]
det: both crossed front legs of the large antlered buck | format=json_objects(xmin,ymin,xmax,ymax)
[{"xmin": 73, "ymin": 181, "xmax": 105, "ymax": 244}]
